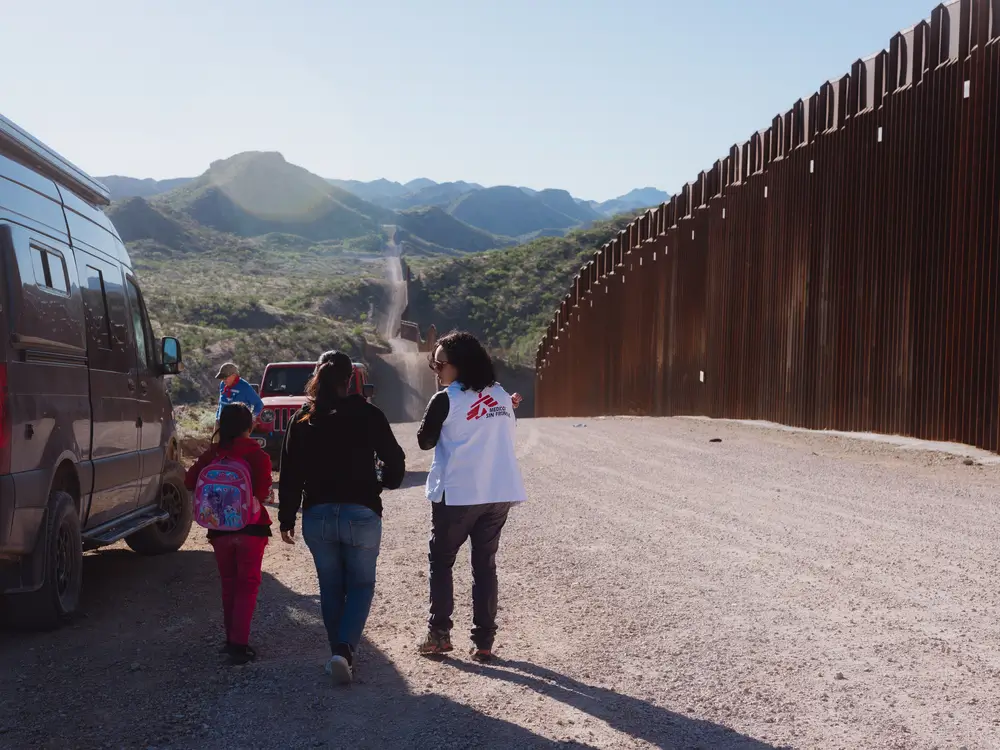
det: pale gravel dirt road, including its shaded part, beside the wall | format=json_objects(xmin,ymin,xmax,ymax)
[{"xmin": 0, "ymin": 419, "xmax": 1000, "ymax": 750}]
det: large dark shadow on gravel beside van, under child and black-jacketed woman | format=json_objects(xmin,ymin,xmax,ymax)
[{"xmin": 0, "ymin": 547, "xmax": 584, "ymax": 750}]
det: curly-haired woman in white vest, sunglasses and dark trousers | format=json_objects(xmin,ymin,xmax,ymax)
[{"xmin": 417, "ymin": 332, "xmax": 527, "ymax": 661}]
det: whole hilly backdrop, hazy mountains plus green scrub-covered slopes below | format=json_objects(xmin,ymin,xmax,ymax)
[{"xmin": 104, "ymin": 152, "xmax": 658, "ymax": 403}]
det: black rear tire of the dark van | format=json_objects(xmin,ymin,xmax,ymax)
[{"xmin": 7, "ymin": 491, "xmax": 83, "ymax": 630}]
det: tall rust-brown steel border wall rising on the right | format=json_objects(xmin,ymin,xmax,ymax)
[{"xmin": 536, "ymin": 0, "xmax": 1000, "ymax": 451}]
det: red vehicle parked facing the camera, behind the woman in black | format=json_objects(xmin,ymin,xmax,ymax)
[{"xmin": 251, "ymin": 362, "xmax": 375, "ymax": 471}]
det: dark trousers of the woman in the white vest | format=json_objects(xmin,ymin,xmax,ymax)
[{"xmin": 428, "ymin": 501, "xmax": 512, "ymax": 649}]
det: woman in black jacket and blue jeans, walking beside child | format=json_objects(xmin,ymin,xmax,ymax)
[{"xmin": 278, "ymin": 352, "xmax": 406, "ymax": 682}]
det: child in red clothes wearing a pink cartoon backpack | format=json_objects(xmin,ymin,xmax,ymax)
[{"xmin": 185, "ymin": 403, "xmax": 271, "ymax": 664}]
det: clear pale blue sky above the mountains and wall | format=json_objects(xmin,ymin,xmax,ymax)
[{"xmin": 0, "ymin": 0, "xmax": 934, "ymax": 199}]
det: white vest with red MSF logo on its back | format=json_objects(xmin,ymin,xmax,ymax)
[{"xmin": 427, "ymin": 383, "xmax": 527, "ymax": 505}]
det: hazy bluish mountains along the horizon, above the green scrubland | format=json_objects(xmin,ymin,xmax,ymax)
[{"xmin": 99, "ymin": 160, "xmax": 668, "ymax": 254}]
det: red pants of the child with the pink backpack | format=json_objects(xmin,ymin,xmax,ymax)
[{"xmin": 212, "ymin": 534, "xmax": 267, "ymax": 646}]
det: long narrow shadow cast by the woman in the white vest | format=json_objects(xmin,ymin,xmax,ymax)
[{"xmin": 443, "ymin": 659, "xmax": 775, "ymax": 750}]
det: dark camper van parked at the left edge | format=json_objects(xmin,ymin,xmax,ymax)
[{"xmin": 0, "ymin": 117, "xmax": 191, "ymax": 627}]
